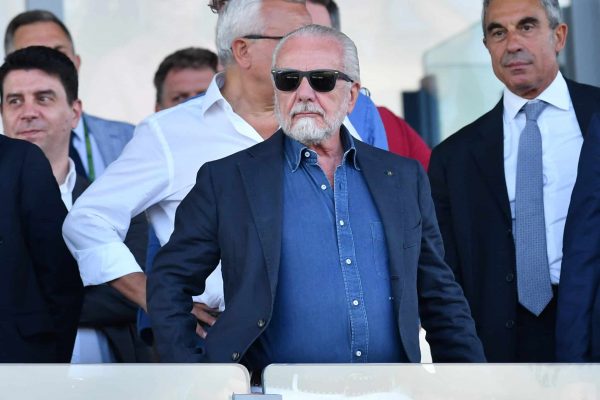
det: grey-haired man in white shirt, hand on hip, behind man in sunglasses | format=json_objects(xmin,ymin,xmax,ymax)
[{"xmin": 63, "ymin": 0, "xmax": 311, "ymax": 336}]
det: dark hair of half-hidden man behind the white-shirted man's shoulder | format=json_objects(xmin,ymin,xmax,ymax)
[{"xmin": 154, "ymin": 47, "xmax": 219, "ymax": 103}]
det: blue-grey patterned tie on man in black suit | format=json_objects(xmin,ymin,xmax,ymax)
[{"xmin": 515, "ymin": 101, "xmax": 552, "ymax": 316}]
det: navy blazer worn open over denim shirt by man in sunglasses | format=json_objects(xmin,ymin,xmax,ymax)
[{"xmin": 148, "ymin": 131, "xmax": 485, "ymax": 362}]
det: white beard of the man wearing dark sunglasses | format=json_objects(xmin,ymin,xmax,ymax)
[{"xmin": 275, "ymin": 91, "xmax": 350, "ymax": 146}]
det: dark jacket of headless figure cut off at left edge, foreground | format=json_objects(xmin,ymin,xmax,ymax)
[{"xmin": 0, "ymin": 135, "xmax": 83, "ymax": 363}]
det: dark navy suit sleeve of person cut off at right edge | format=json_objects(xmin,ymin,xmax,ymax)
[{"xmin": 556, "ymin": 114, "xmax": 600, "ymax": 362}]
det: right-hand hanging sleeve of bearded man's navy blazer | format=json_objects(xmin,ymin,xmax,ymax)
[{"xmin": 417, "ymin": 165, "xmax": 485, "ymax": 362}]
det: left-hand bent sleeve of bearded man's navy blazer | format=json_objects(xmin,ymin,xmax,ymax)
[{"xmin": 147, "ymin": 163, "xmax": 220, "ymax": 362}]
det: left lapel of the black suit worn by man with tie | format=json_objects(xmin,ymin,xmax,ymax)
[{"xmin": 470, "ymin": 99, "xmax": 511, "ymax": 221}]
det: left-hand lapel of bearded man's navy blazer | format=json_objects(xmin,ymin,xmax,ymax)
[{"xmin": 238, "ymin": 131, "xmax": 283, "ymax": 296}]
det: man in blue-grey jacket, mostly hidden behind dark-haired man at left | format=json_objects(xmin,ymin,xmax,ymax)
[{"xmin": 4, "ymin": 10, "xmax": 134, "ymax": 181}]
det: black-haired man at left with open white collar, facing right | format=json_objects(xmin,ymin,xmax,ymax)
[{"xmin": 1, "ymin": 46, "xmax": 149, "ymax": 362}]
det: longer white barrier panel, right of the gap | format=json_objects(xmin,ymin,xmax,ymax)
[{"xmin": 263, "ymin": 364, "xmax": 600, "ymax": 400}]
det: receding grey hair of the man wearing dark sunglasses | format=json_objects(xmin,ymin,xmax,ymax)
[{"xmin": 272, "ymin": 24, "xmax": 360, "ymax": 82}]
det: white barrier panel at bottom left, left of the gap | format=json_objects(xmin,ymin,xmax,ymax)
[{"xmin": 0, "ymin": 364, "xmax": 250, "ymax": 400}]
